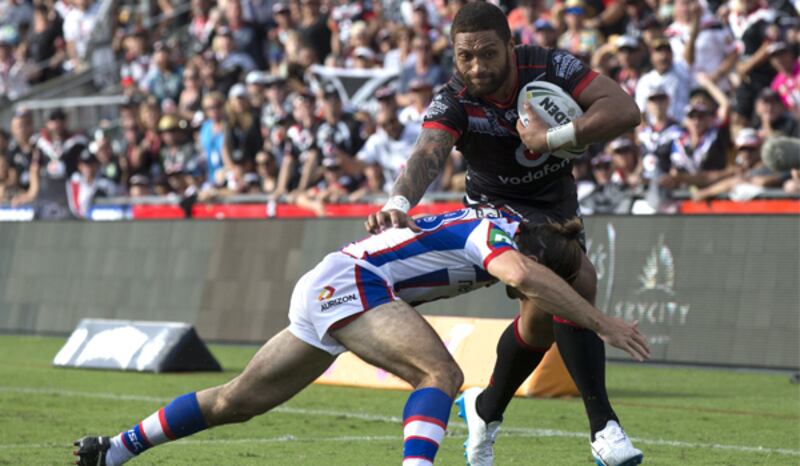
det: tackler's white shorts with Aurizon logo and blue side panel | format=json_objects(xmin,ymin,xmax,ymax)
[{"xmin": 289, "ymin": 252, "xmax": 399, "ymax": 356}]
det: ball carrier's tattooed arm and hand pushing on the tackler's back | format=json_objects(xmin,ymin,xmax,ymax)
[{"xmin": 365, "ymin": 128, "xmax": 455, "ymax": 233}]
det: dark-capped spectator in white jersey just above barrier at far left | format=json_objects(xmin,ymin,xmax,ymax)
[{"xmin": 66, "ymin": 149, "xmax": 119, "ymax": 218}]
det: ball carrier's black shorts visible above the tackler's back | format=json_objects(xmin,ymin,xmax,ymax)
[{"xmin": 464, "ymin": 196, "xmax": 586, "ymax": 252}]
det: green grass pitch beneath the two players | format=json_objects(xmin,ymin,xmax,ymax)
[{"xmin": 0, "ymin": 336, "xmax": 800, "ymax": 466}]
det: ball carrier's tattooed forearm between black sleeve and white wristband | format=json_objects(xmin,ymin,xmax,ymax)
[{"xmin": 392, "ymin": 129, "xmax": 455, "ymax": 206}]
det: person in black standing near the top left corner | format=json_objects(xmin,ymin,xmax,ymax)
[{"xmin": 28, "ymin": 4, "xmax": 66, "ymax": 83}]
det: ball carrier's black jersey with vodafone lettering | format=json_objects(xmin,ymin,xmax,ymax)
[{"xmin": 422, "ymin": 45, "xmax": 597, "ymax": 205}]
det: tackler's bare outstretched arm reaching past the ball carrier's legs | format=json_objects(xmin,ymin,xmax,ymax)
[{"xmin": 487, "ymin": 251, "xmax": 650, "ymax": 361}]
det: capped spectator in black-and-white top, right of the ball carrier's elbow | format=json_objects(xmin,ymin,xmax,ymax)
[{"xmin": 660, "ymin": 104, "xmax": 731, "ymax": 188}]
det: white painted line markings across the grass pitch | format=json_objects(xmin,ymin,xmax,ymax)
[{"xmin": 0, "ymin": 386, "xmax": 800, "ymax": 456}]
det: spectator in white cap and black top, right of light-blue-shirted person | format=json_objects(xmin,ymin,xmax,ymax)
[{"xmin": 225, "ymin": 84, "xmax": 263, "ymax": 171}]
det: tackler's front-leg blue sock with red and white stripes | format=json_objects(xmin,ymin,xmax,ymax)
[{"xmin": 403, "ymin": 387, "xmax": 453, "ymax": 466}]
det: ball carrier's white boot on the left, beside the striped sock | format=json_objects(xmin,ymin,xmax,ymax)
[{"xmin": 456, "ymin": 387, "xmax": 500, "ymax": 466}]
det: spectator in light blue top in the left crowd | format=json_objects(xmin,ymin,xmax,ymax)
[{"xmin": 200, "ymin": 92, "xmax": 232, "ymax": 185}]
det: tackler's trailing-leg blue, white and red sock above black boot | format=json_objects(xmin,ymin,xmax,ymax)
[{"xmin": 106, "ymin": 392, "xmax": 208, "ymax": 466}]
